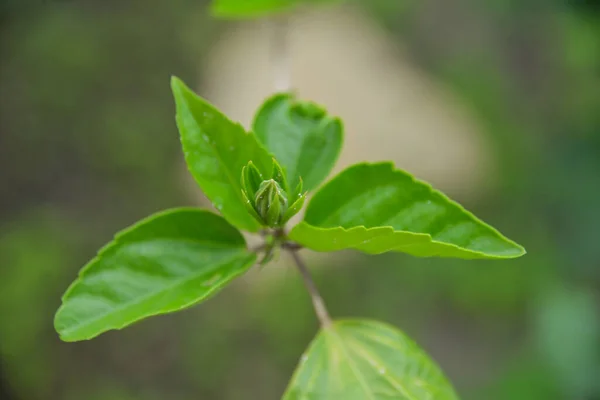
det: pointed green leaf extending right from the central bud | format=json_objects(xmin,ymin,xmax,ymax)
[{"xmin": 290, "ymin": 163, "xmax": 525, "ymax": 259}]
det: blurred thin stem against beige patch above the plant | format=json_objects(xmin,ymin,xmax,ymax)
[{"xmin": 270, "ymin": 14, "xmax": 291, "ymax": 92}]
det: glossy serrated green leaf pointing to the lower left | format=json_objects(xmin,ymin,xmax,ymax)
[{"xmin": 54, "ymin": 208, "xmax": 256, "ymax": 342}]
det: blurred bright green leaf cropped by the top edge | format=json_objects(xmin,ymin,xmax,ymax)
[{"xmin": 212, "ymin": 0, "xmax": 341, "ymax": 18}]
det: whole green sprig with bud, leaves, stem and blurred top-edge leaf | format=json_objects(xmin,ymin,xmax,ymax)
[{"xmin": 54, "ymin": 0, "xmax": 525, "ymax": 400}]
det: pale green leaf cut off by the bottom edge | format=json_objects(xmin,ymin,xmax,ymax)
[{"xmin": 283, "ymin": 320, "xmax": 458, "ymax": 400}]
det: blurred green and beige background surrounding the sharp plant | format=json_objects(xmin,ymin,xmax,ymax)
[{"xmin": 0, "ymin": 0, "xmax": 600, "ymax": 400}]
